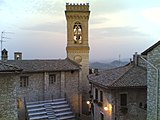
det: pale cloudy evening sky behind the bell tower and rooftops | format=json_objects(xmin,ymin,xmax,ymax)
[{"xmin": 0, "ymin": 0, "xmax": 160, "ymax": 61}]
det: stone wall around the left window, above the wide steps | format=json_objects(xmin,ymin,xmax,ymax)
[{"xmin": 17, "ymin": 73, "xmax": 44, "ymax": 102}]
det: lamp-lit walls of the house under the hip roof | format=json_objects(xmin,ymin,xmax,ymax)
[{"xmin": 91, "ymin": 85, "xmax": 147, "ymax": 120}]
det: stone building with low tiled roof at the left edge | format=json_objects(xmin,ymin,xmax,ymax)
[{"xmin": 0, "ymin": 63, "xmax": 21, "ymax": 120}]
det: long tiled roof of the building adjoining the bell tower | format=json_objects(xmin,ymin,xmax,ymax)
[{"xmin": 2, "ymin": 59, "xmax": 80, "ymax": 72}]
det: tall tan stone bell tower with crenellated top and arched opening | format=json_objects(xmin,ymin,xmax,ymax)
[{"xmin": 65, "ymin": 3, "xmax": 90, "ymax": 113}]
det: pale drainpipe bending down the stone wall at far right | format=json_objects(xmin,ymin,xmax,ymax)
[{"xmin": 140, "ymin": 55, "xmax": 159, "ymax": 120}]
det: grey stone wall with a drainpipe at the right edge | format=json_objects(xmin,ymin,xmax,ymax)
[{"xmin": 147, "ymin": 45, "xmax": 160, "ymax": 120}]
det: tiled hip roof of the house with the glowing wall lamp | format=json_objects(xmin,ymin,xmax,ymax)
[{"xmin": 88, "ymin": 64, "xmax": 147, "ymax": 88}]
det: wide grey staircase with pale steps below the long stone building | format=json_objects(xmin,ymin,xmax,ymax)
[{"xmin": 26, "ymin": 98, "xmax": 75, "ymax": 120}]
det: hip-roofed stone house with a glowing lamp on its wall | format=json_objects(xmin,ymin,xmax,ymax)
[{"xmin": 88, "ymin": 54, "xmax": 147, "ymax": 120}]
